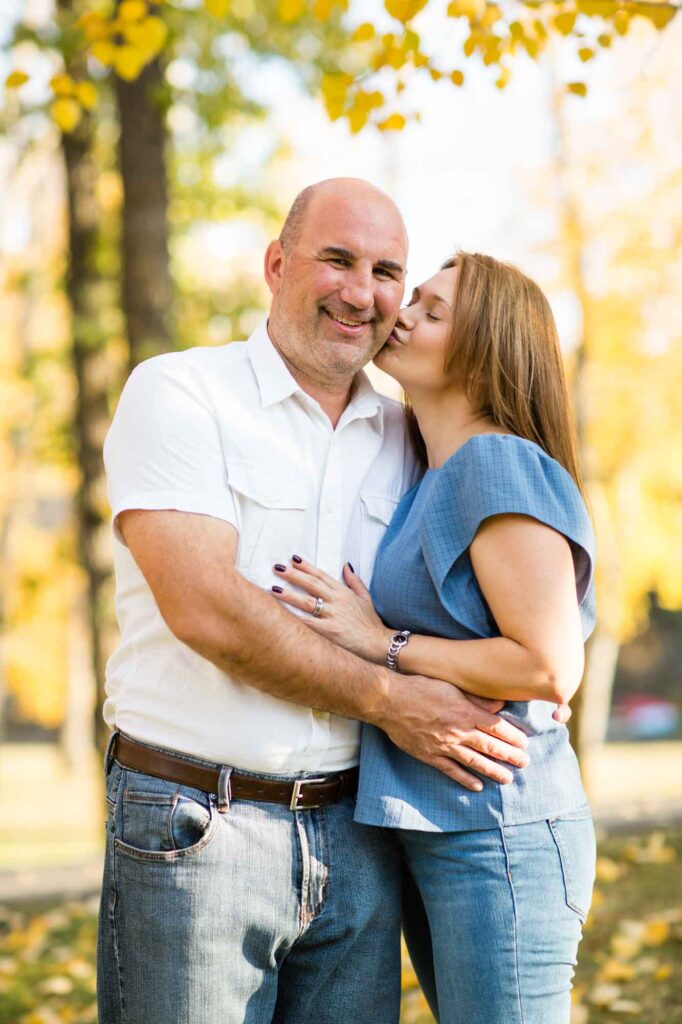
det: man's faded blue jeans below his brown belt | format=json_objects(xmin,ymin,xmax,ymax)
[{"xmin": 97, "ymin": 749, "xmax": 400, "ymax": 1024}]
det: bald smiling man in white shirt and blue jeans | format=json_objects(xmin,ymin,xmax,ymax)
[{"xmin": 99, "ymin": 179, "xmax": 527, "ymax": 1024}]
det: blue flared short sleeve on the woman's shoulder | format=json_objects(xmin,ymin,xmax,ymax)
[{"xmin": 421, "ymin": 434, "xmax": 595, "ymax": 635}]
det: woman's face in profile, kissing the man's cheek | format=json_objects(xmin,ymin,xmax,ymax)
[{"xmin": 374, "ymin": 267, "xmax": 459, "ymax": 394}]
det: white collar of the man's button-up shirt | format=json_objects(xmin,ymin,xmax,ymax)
[{"xmin": 247, "ymin": 321, "xmax": 384, "ymax": 433}]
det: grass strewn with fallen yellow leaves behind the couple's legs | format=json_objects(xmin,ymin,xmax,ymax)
[{"xmin": 0, "ymin": 831, "xmax": 682, "ymax": 1024}]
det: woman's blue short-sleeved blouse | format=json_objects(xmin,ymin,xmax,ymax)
[{"xmin": 355, "ymin": 434, "xmax": 595, "ymax": 831}]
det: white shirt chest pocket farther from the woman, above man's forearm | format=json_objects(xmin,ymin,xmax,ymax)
[{"xmin": 228, "ymin": 463, "xmax": 310, "ymax": 579}]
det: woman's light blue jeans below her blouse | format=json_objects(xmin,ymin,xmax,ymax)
[{"xmin": 398, "ymin": 808, "xmax": 595, "ymax": 1024}]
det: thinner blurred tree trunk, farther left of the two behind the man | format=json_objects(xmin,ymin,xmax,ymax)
[{"xmin": 61, "ymin": 118, "xmax": 111, "ymax": 761}]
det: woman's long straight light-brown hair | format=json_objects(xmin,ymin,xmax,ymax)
[{"xmin": 406, "ymin": 252, "xmax": 585, "ymax": 496}]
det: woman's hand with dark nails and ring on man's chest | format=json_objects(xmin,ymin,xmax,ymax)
[{"xmin": 272, "ymin": 555, "xmax": 395, "ymax": 665}]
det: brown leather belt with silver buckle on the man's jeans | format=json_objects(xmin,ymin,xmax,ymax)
[{"xmin": 111, "ymin": 732, "xmax": 358, "ymax": 811}]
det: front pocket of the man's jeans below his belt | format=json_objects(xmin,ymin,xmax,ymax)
[{"xmin": 116, "ymin": 773, "xmax": 218, "ymax": 860}]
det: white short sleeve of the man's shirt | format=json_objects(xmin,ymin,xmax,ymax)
[{"xmin": 104, "ymin": 353, "xmax": 238, "ymax": 541}]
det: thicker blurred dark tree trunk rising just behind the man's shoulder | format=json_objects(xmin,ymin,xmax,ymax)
[{"xmin": 116, "ymin": 60, "xmax": 173, "ymax": 369}]
